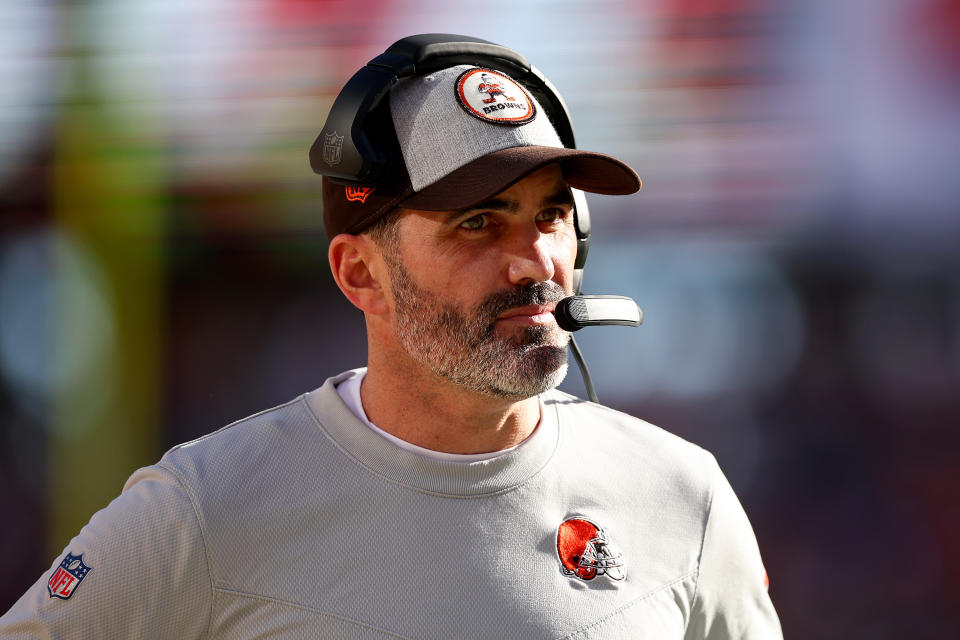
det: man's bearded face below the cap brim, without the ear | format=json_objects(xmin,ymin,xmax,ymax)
[{"xmin": 384, "ymin": 166, "xmax": 576, "ymax": 398}]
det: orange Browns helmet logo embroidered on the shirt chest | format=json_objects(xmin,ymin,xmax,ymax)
[{"xmin": 557, "ymin": 516, "xmax": 626, "ymax": 582}]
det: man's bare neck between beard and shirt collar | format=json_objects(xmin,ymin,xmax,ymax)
[{"xmin": 360, "ymin": 353, "xmax": 540, "ymax": 453}]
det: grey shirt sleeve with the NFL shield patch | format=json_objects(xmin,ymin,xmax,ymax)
[{"xmin": 0, "ymin": 466, "xmax": 212, "ymax": 639}]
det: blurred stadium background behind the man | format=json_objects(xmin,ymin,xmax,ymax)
[{"xmin": 0, "ymin": 0, "xmax": 960, "ymax": 639}]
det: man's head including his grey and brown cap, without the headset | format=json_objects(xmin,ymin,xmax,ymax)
[{"xmin": 311, "ymin": 35, "xmax": 640, "ymax": 398}]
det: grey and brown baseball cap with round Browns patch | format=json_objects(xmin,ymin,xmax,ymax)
[{"xmin": 323, "ymin": 65, "xmax": 641, "ymax": 238}]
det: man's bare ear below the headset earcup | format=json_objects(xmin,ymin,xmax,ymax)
[{"xmin": 327, "ymin": 233, "xmax": 388, "ymax": 315}]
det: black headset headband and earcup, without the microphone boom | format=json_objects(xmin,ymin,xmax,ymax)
[{"xmin": 310, "ymin": 33, "xmax": 590, "ymax": 293}]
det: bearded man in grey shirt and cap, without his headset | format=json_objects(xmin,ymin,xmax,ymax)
[{"xmin": 0, "ymin": 36, "xmax": 780, "ymax": 638}]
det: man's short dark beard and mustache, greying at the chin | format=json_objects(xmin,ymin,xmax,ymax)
[{"xmin": 388, "ymin": 260, "xmax": 570, "ymax": 399}]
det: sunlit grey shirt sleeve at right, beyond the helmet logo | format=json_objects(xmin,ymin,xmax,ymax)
[{"xmin": 686, "ymin": 456, "xmax": 783, "ymax": 640}]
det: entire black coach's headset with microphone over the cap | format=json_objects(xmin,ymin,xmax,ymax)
[{"xmin": 310, "ymin": 33, "xmax": 643, "ymax": 402}]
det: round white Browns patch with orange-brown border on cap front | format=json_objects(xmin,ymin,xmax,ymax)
[{"xmin": 456, "ymin": 69, "xmax": 537, "ymax": 125}]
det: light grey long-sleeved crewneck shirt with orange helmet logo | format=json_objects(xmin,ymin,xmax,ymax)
[{"xmin": 0, "ymin": 372, "xmax": 781, "ymax": 639}]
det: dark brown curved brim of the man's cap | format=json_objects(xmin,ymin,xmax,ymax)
[{"xmin": 399, "ymin": 146, "xmax": 642, "ymax": 211}]
